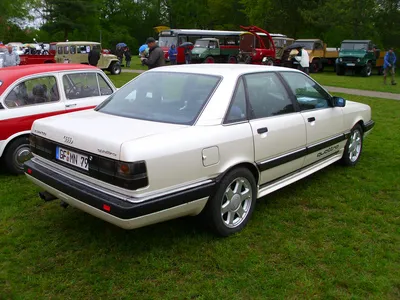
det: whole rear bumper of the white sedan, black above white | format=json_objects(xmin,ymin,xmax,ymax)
[{"xmin": 25, "ymin": 160, "xmax": 215, "ymax": 229}]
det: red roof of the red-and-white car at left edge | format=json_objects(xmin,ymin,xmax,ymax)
[{"xmin": 0, "ymin": 63, "xmax": 98, "ymax": 95}]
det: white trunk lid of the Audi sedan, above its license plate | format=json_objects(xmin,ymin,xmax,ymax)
[{"xmin": 32, "ymin": 110, "xmax": 188, "ymax": 160}]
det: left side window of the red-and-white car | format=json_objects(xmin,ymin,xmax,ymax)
[{"xmin": 4, "ymin": 76, "xmax": 60, "ymax": 108}]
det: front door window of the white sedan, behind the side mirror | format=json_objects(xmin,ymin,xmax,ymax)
[{"xmin": 281, "ymin": 72, "xmax": 330, "ymax": 110}]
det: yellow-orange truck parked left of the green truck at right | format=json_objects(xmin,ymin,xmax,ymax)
[{"xmin": 291, "ymin": 39, "xmax": 339, "ymax": 73}]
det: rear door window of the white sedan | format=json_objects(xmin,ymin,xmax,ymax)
[{"xmin": 245, "ymin": 72, "xmax": 294, "ymax": 119}]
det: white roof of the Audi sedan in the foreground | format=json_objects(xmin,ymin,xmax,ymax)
[{"xmin": 146, "ymin": 64, "xmax": 300, "ymax": 77}]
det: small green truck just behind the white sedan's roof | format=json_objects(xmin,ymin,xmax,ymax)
[{"xmin": 192, "ymin": 38, "xmax": 239, "ymax": 63}]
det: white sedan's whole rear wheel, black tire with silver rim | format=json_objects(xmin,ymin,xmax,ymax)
[{"xmin": 204, "ymin": 168, "xmax": 257, "ymax": 237}]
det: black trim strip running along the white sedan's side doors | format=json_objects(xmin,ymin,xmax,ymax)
[{"xmin": 257, "ymin": 134, "xmax": 348, "ymax": 172}]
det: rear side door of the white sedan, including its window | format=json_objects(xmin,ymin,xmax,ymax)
[{"xmin": 244, "ymin": 72, "xmax": 306, "ymax": 184}]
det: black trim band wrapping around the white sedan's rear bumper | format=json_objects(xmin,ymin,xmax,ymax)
[{"xmin": 24, "ymin": 160, "xmax": 216, "ymax": 219}]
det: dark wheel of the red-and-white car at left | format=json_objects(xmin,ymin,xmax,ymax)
[{"xmin": 4, "ymin": 136, "xmax": 31, "ymax": 175}]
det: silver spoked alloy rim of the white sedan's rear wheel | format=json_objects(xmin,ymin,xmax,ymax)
[{"xmin": 221, "ymin": 177, "xmax": 253, "ymax": 228}]
